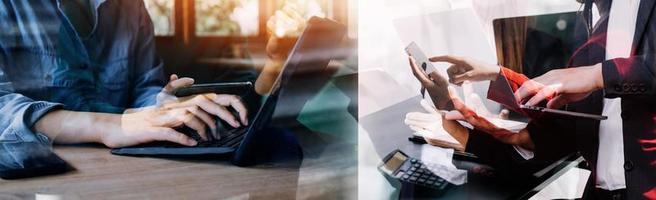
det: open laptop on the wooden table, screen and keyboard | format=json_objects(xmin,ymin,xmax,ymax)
[{"xmin": 111, "ymin": 17, "xmax": 346, "ymax": 166}]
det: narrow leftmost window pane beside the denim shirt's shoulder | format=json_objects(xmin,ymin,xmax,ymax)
[{"xmin": 144, "ymin": 0, "xmax": 175, "ymax": 36}]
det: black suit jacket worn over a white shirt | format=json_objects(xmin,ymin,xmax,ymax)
[{"xmin": 467, "ymin": 0, "xmax": 656, "ymax": 199}]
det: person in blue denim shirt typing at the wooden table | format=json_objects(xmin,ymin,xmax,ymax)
[{"xmin": 0, "ymin": 0, "xmax": 248, "ymax": 152}]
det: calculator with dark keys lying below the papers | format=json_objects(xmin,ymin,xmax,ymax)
[{"xmin": 378, "ymin": 149, "xmax": 452, "ymax": 193}]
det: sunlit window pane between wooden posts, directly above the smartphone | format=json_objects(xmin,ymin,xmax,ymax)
[{"xmin": 196, "ymin": 0, "xmax": 259, "ymax": 36}]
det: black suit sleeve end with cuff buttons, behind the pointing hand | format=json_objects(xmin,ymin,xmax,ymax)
[{"xmin": 601, "ymin": 54, "xmax": 656, "ymax": 98}]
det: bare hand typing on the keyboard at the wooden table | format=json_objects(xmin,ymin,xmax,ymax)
[{"xmin": 106, "ymin": 76, "xmax": 248, "ymax": 148}]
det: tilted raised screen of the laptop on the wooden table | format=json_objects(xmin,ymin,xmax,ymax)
[{"xmin": 233, "ymin": 17, "xmax": 346, "ymax": 165}]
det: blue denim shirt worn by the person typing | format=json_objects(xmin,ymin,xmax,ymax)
[{"xmin": 0, "ymin": 0, "xmax": 166, "ymax": 144}]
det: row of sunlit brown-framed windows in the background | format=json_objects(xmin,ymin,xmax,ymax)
[{"xmin": 144, "ymin": 0, "xmax": 358, "ymax": 38}]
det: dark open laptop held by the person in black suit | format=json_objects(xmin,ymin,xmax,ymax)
[{"xmin": 488, "ymin": 12, "xmax": 608, "ymax": 120}]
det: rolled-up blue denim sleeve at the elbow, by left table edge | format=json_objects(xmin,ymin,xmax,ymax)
[{"xmin": 0, "ymin": 93, "xmax": 65, "ymax": 178}]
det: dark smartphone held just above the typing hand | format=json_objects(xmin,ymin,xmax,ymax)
[{"xmin": 173, "ymin": 82, "xmax": 253, "ymax": 97}]
